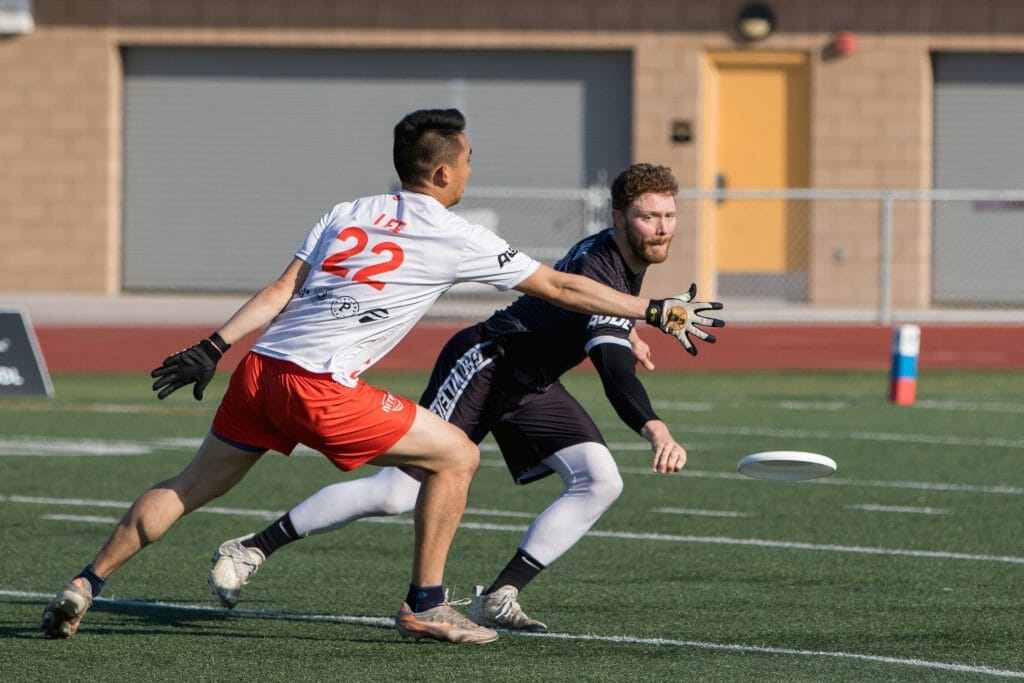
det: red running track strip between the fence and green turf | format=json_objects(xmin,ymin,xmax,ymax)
[{"xmin": 36, "ymin": 322, "xmax": 1024, "ymax": 372}]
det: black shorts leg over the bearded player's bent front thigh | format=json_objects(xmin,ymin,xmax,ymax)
[{"xmin": 492, "ymin": 382, "xmax": 604, "ymax": 483}]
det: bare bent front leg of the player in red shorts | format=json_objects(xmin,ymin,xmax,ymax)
[{"xmin": 371, "ymin": 407, "xmax": 480, "ymax": 586}]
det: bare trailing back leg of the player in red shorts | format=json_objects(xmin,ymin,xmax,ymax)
[{"xmin": 92, "ymin": 434, "xmax": 263, "ymax": 579}]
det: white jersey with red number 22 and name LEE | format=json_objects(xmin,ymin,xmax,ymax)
[{"xmin": 253, "ymin": 191, "xmax": 540, "ymax": 386}]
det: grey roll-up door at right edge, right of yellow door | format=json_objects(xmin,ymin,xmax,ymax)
[{"xmin": 933, "ymin": 54, "xmax": 1024, "ymax": 305}]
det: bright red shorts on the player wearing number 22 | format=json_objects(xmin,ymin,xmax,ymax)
[{"xmin": 213, "ymin": 352, "xmax": 417, "ymax": 471}]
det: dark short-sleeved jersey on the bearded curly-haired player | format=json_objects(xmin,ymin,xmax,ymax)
[{"xmin": 481, "ymin": 227, "xmax": 643, "ymax": 389}]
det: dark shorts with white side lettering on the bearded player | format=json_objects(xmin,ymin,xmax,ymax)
[{"xmin": 420, "ymin": 326, "xmax": 604, "ymax": 483}]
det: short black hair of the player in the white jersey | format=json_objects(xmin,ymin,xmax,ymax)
[{"xmin": 394, "ymin": 110, "xmax": 466, "ymax": 183}]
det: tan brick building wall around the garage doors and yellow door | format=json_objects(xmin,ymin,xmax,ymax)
[{"xmin": 6, "ymin": 0, "xmax": 1024, "ymax": 305}]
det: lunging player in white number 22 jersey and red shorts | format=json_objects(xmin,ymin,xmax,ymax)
[{"xmin": 42, "ymin": 110, "xmax": 720, "ymax": 643}]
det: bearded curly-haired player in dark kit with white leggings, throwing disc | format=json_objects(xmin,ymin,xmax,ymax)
[{"xmin": 210, "ymin": 164, "xmax": 724, "ymax": 631}]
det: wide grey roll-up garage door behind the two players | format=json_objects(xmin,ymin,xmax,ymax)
[{"xmin": 123, "ymin": 48, "xmax": 632, "ymax": 292}]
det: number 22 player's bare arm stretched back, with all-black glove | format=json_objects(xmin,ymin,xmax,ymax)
[{"xmin": 150, "ymin": 258, "xmax": 309, "ymax": 400}]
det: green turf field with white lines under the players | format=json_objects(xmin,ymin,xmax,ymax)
[{"xmin": 0, "ymin": 372, "xmax": 1024, "ymax": 682}]
